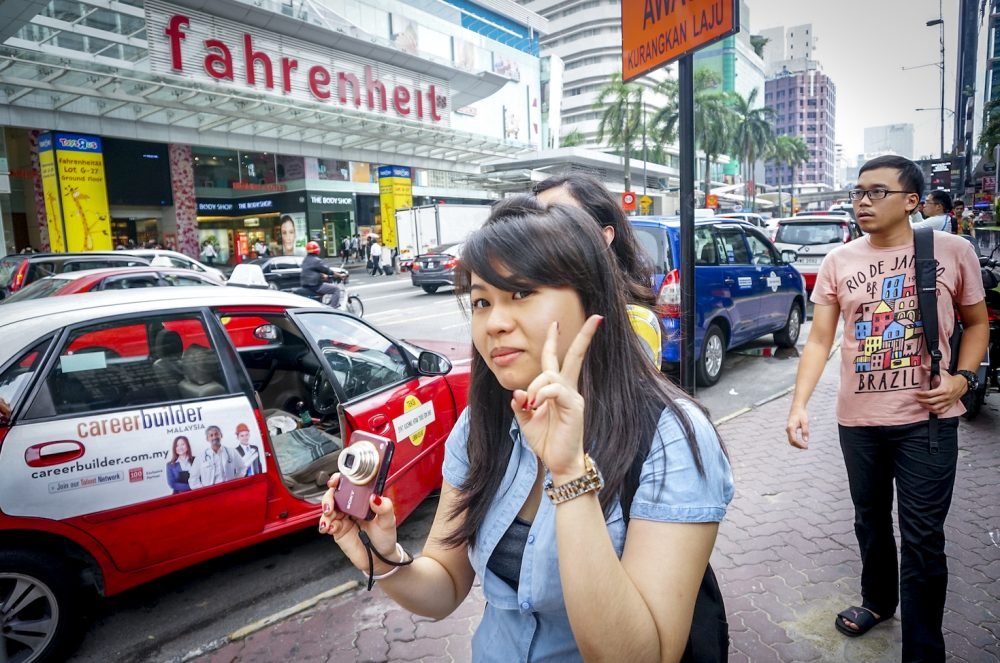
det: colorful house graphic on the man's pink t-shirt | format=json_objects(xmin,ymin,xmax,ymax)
[{"xmin": 854, "ymin": 274, "xmax": 923, "ymax": 373}]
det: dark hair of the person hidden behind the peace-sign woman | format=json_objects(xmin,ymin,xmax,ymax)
[{"xmin": 532, "ymin": 173, "xmax": 656, "ymax": 308}]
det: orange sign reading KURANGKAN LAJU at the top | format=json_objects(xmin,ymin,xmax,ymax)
[{"xmin": 622, "ymin": 0, "xmax": 740, "ymax": 81}]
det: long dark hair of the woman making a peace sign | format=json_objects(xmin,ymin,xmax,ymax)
[{"xmin": 445, "ymin": 196, "xmax": 704, "ymax": 545}]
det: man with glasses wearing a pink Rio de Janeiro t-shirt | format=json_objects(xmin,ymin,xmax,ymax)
[{"xmin": 786, "ymin": 155, "xmax": 989, "ymax": 663}]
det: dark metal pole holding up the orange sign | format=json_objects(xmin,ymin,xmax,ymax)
[{"xmin": 677, "ymin": 52, "xmax": 695, "ymax": 394}]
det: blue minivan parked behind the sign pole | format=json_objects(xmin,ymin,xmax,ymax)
[{"xmin": 629, "ymin": 216, "xmax": 806, "ymax": 387}]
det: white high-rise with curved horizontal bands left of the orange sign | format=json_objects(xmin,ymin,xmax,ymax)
[{"xmin": 518, "ymin": 0, "xmax": 673, "ymax": 147}]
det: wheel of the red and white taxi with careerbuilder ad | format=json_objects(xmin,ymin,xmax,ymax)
[{"xmin": 0, "ymin": 551, "xmax": 90, "ymax": 663}]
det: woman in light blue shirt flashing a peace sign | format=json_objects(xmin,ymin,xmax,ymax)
[{"xmin": 320, "ymin": 197, "xmax": 733, "ymax": 662}]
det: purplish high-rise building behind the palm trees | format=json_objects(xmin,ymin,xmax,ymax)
[{"xmin": 764, "ymin": 68, "xmax": 837, "ymax": 190}]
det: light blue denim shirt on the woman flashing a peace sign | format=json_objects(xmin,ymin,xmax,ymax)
[{"xmin": 443, "ymin": 401, "xmax": 733, "ymax": 663}]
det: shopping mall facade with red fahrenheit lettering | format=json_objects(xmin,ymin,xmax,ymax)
[{"xmin": 0, "ymin": 0, "xmax": 547, "ymax": 262}]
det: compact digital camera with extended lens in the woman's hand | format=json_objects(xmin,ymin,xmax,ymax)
[{"xmin": 333, "ymin": 431, "xmax": 396, "ymax": 520}]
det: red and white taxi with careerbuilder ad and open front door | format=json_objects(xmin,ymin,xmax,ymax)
[{"xmin": 0, "ymin": 287, "xmax": 470, "ymax": 661}]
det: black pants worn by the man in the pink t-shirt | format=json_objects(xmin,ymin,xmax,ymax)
[{"xmin": 840, "ymin": 417, "xmax": 958, "ymax": 663}]
